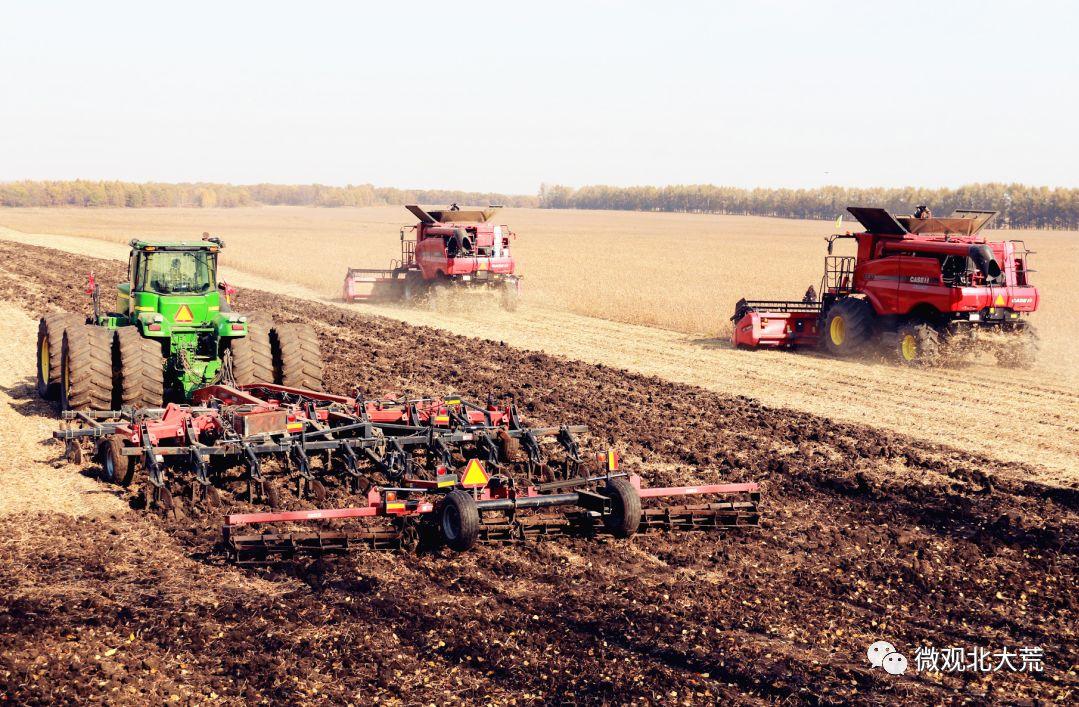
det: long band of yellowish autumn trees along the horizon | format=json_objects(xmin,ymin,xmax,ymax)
[{"xmin": 0, "ymin": 179, "xmax": 1079, "ymax": 230}]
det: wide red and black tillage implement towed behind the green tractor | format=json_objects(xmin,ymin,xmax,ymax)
[{"xmin": 54, "ymin": 383, "xmax": 760, "ymax": 563}]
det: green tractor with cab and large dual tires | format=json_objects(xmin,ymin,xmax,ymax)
[{"xmin": 38, "ymin": 234, "xmax": 323, "ymax": 410}]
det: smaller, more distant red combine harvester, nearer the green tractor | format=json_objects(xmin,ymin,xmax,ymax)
[{"xmin": 343, "ymin": 204, "xmax": 520, "ymax": 312}]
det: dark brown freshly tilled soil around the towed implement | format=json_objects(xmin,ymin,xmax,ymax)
[{"xmin": 0, "ymin": 244, "xmax": 1079, "ymax": 704}]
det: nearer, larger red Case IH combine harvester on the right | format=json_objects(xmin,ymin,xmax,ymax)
[{"xmin": 730, "ymin": 207, "xmax": 1038, "ymax": 366}]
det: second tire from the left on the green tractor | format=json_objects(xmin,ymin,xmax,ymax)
[{"xmin": 60, "ymin": 324, "xmax": 113, "ymax": 410}]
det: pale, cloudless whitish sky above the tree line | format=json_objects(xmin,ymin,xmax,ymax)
[{"xmin": 0, "ymin": 0, "xmax": 1079, "ymax": 193}]
